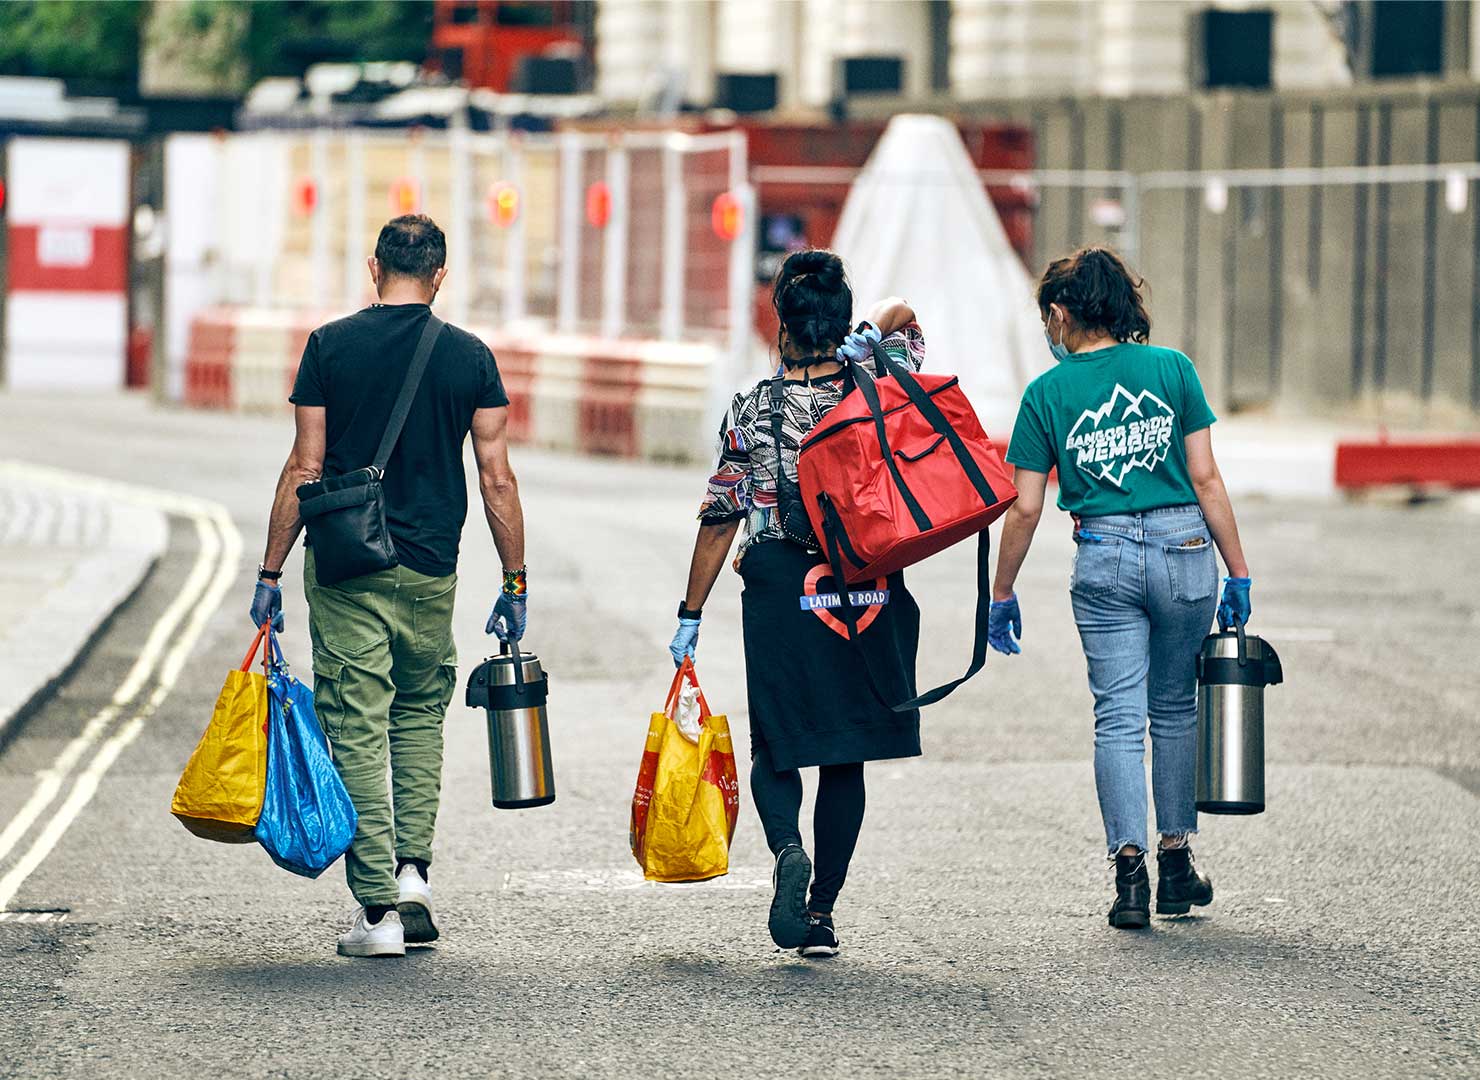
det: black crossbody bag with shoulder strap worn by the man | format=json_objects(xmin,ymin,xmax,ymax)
[{"xmin": 297, "ymin": 314, "xmax": 447, "ymax": 584}]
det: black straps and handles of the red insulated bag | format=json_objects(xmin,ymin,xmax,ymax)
[{"xmin": 818, "ymin": 342, "xmax": 998, "ymax": 713}]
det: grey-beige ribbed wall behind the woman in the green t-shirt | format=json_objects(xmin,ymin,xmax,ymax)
[{"xmin": 963, "ymin": 83, "xmax": 1480, "ymax": 428}]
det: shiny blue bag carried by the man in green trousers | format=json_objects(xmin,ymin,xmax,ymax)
[{"xmin": 256, "ymin": 632, "xmax": 360, "ymax": 877}]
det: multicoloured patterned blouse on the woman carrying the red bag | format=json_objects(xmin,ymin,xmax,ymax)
[{"xmin": 699, "ymin": 323, "xmax": 925, "ymax": 568}]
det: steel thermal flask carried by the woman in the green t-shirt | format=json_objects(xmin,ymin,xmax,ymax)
[{"xmin": 1197, "ymin": 623, "xmax": 1285, "ymax": 814}]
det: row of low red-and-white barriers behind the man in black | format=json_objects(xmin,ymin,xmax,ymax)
[{"xmin": 184, "ymin": 308, "xmax": 721, "ymax": 462}]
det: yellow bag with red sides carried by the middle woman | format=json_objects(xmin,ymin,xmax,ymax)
[{"xmin": 630, "ymin": 657, "xmax": 740, "ymax": 882}]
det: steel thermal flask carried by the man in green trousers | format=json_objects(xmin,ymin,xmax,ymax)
[{"xmin": 468, "ymin": 642, "xmax": 555, "ymax": 809}]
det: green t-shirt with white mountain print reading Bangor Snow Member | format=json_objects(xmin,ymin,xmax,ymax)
[{"xmin": 1008, "ymin": 343, "xmax": 1218, "ymax": 518}]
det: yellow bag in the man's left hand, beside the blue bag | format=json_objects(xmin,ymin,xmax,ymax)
[{"xmin": 170, "ymin": 624, "xmax": 269, "ymax": 843}]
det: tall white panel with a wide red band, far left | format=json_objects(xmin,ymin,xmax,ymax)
[{"xmin": 6, "ymin": 138, "xmax": 129, "ymax": 391}]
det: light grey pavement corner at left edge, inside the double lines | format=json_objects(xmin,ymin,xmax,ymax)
[{"xmin": 0, "ymin": 460, "xmax": 167, "ymax": 741}]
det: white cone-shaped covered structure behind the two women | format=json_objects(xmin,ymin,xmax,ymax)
[{"xmin": 833, "ymin": 115, "xmax": 1052, "ymax": 432}]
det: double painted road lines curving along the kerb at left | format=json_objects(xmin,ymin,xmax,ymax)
[{"xmin": 0, "ymin": 462, "xmax": 241, "ymax": 908}]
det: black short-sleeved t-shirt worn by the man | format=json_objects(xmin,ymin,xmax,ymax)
[{"xmin": 289, "ymin": 303, "xmax": 509, "ymax": 577}]
